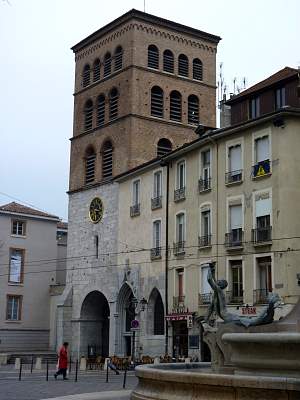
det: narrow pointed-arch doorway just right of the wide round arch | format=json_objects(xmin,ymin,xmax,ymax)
[{"xmin": 117, "ymin": 283, "xmax": 135, "ymax": 356}]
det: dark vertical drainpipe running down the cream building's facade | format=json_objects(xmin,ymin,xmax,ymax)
[{"xmin": 161, "ymin": 160, "xmax": 170, "ymax": 354}]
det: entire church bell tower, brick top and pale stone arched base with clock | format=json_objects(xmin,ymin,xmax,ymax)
[{"xmin": 56, "ymin": 10, "xmax": 220, "ymax": 356}]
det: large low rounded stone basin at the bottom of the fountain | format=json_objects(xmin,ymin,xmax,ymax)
[{"xmin": 131, "ymin": 363, "xmax": 300, "ymax": 400}]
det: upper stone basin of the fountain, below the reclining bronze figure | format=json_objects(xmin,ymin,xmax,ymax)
[{"xmin": 222, "ymin": 332, "xmax": 300, "ymax": 378}]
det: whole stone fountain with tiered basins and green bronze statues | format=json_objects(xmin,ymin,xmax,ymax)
[{"xmin": 131, "ymin": 263, "xmax": 300, "ymax": 400}]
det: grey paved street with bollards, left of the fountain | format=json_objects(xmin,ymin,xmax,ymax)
[{"xmin": 0, "ymin": 366, "xmax": 137, "ymax": 400}]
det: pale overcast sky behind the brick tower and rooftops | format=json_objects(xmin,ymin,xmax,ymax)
[{"xmin": 0, "ymin": 0, "xmax": 300, "ymax": 219}]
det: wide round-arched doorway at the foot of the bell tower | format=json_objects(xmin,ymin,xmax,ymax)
[{"xmin": 80, "ymin": 290, "xmax": 110, "ymax": 357}]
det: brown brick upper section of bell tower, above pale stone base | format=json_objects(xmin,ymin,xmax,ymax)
[{"xmin": 69, "ymin": 10, "xmax": 220, "ymax": 191}]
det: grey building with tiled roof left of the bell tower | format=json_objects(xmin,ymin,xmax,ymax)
[{"xmin": 0, "ymin": 202, "xmax": 67, "ymax": 352}]
